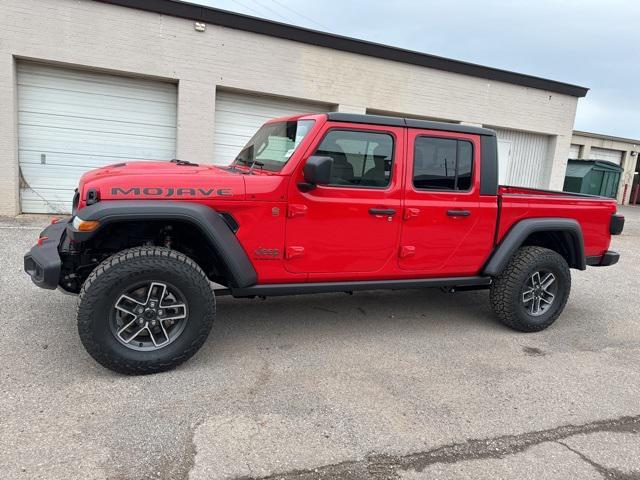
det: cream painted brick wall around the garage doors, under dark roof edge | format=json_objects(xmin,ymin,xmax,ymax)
[{"xmin": 0, "ymin": 0, "xmax": 577, "ymax": 215}]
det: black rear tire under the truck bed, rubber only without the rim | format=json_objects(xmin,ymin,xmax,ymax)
[{"xmin": 489, "ymin": 247, "xmax": 571, "ymax": 332}]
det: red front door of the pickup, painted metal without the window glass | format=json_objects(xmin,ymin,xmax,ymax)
[{"xmin": 286, "ymin": 122, "xmax": 404, "ymax": 281}]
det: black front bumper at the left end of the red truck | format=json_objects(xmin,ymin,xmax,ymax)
[{"xmin": 24, "ymin": 221, "xmax": 68, "ymax": 290}]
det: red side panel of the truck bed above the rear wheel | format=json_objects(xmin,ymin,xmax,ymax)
[{"xmin": 496, "ymin": 187, "xmax": 617, "ymax": 256}]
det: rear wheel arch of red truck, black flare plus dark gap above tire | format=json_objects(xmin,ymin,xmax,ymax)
[{"xmin": 483, "ymin": 218, "xmax": 587, "ymax": 276}]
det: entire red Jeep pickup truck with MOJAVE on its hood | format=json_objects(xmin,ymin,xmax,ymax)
[{"xmin": 24, "ymin": 113, "xmax": 624, "ymax": 374}]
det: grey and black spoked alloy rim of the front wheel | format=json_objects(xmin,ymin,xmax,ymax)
[{"xmin": 109, "ymin": 281, "xmax": 188, "ymax": 351}]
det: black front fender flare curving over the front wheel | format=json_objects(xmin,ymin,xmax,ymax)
[{"xmin": 67, "ymin": 200, "xmax": 258, "ymax": 288}]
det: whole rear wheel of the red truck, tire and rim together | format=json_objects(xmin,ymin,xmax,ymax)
[{"xmin": 490, "ymin": 247, "xmax": 571, "ymax": 332}]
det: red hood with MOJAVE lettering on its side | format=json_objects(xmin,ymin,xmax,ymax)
[{"xmin": 78, "ymin": 161, "xmax": 246, "ymax": 208}]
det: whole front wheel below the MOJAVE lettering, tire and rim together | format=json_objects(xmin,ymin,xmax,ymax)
[{"xmin": 78, "ymin": 247, "xmax": 215, "ymax": 375}]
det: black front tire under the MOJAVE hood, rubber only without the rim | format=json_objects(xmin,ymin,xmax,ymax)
[{"xmin": 78, "ymin": 247, "xmax": 215, "ymax": 375}]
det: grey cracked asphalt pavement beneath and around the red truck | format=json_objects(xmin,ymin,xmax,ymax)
[{"xmin": 0, "ymin": 207, "xmax": 640, "ymax": 480}]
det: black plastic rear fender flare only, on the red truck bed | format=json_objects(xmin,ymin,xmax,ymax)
[{"xmin": 482, "ymin": 218, "xmax": 587, "ymax": 277}]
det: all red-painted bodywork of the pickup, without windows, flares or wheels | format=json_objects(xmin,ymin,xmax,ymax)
[{"xmin": 78, "ymin": 115, "xmax": 616, "ymax": 284}]
